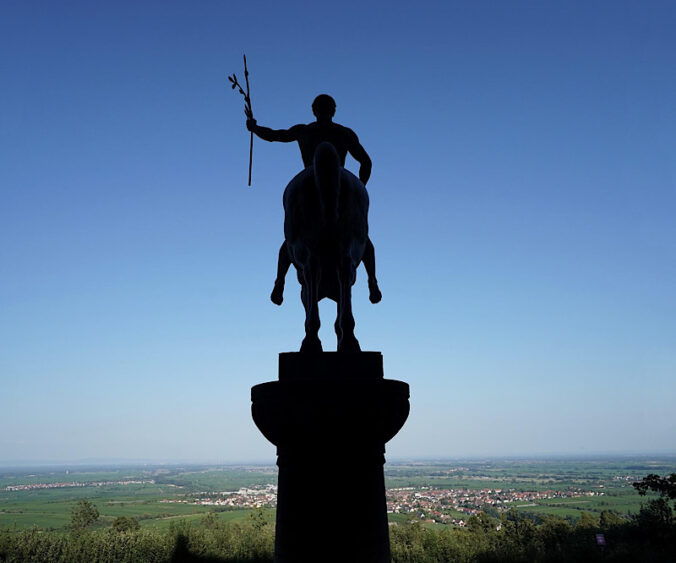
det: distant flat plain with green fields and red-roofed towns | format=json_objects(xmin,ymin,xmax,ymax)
[{"xmin": 0, "ymin": 456, "xmax": 676, "ymax": 533}]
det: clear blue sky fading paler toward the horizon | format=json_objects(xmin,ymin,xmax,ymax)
[{"xmin": 0, "ymin": 1, "xmax": 676, "ymax": 462}]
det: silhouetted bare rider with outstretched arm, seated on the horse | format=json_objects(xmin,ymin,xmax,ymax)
[{"xmin": 246, "ymin": 94, "xmax": 382, "ymax": 305}]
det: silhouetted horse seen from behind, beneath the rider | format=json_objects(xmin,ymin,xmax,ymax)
[{"xmin": 284, "ymin": 142, "xmax": 369, "ymax": 352}]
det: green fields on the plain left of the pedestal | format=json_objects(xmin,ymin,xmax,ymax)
[{"xmin": 0, "ymin": 466, "xmax": 277, "ymax": 532}]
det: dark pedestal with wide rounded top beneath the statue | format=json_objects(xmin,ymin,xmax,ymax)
[{"xmin": 251, "ymin": 352, "xmax": 409, "ymax": 563}]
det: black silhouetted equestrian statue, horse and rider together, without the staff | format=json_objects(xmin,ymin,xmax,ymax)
[{"xmin": 247, "ymin": 94, "xmax": 382, "ymax": 352}]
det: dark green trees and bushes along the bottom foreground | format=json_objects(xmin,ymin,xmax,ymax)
[{"xmin": 0, "ymin": 473, "xmax": 676, "ymax": 563}]
